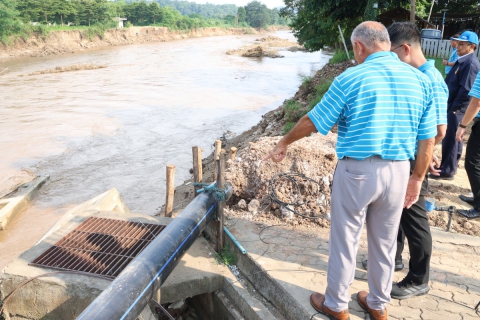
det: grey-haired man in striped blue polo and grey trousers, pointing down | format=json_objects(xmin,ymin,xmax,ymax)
[{"xmin": 265, "ymin": 21, "xmax": 437, "ymax": 319}]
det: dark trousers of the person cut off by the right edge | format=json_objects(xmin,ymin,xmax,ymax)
[{"xmin": 465, "ymin": 121, "xmax": 480, "ymax": 210}]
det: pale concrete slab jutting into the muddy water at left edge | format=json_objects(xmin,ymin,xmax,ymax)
[{"xmin": 0, "ymin": 176, "xmax": 49, "ymax": 230}]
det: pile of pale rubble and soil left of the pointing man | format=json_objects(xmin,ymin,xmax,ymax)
[{"xmin": 226, "ymin": 133, "xmax": 337, "ymax": 227}]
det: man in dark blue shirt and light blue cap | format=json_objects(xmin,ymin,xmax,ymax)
[{"xmin": 430, "ymin": 31, "xmax": 480, "ymax": 180}]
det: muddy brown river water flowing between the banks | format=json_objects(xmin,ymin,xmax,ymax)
[{"xmin": 0, "ymin": 31, "xmax": 329, "ymax": 270}]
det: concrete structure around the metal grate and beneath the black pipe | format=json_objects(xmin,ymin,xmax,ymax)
[{"xmin": 0, "ymin": 189, "xmax": 276, "ymax": 320}]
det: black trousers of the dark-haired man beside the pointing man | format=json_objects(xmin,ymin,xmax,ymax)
[{"xmin": 395, "ymin": 161, "xmax": 432, "ymax": 284}]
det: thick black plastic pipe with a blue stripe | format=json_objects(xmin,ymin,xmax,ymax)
[{"xmin": 77, "ymin": 193, "xmax": 217, "ymax": 320}]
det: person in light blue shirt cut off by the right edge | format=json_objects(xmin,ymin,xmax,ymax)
[{"xmin": 456, "ymin": 73, "xmax": 480, "ymax": 219}]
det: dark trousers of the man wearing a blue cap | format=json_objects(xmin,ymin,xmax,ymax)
[{"xmin": 440, "ymin": 111, "xmax": 463, "ymax": 176}]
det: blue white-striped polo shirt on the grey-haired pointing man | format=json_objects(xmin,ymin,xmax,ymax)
[{"xmin": 308, "ymin": 51, "xmax": 437, "ymax": 160}]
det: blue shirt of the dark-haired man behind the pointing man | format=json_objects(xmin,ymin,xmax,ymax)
[{"xmin": 418, "ymin": 60, "xmax": 448, "ymax": 125}]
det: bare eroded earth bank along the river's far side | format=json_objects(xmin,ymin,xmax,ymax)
[{"xmin": 0, "ymin": 27, "xmax": 280, "ymax": 61}]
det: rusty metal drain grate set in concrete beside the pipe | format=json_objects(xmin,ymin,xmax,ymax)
[{"xmin": 30, "ymin": 217, "xmax": 165, "ymax": 279}]
